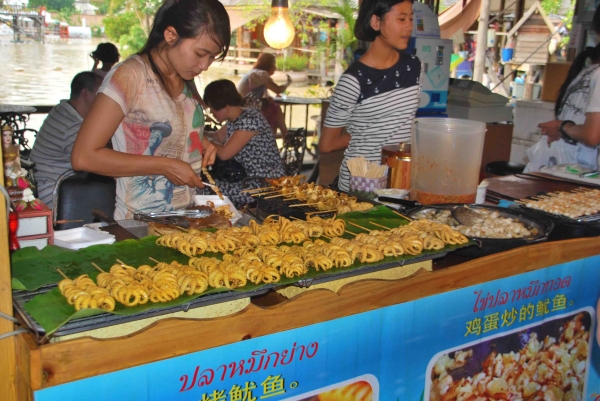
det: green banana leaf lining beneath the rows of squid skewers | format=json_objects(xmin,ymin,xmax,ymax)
[{"xmin": 19, "ymin": 206, "xmax": 474, "ymax": 335}]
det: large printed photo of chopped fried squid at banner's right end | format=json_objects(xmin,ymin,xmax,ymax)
[{"xmin": 424, "ymin": 308, "xmax": 595, "ymax": 401}]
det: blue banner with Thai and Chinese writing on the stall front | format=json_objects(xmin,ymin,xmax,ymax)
[{"xmin": 35, "ymin": 256, "xmax": 600, "ymax": 401}]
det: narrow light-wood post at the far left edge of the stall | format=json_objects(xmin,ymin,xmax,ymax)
[{"xmin": 0, "ymin": 143, "xmax": 18, "ymax": 401}]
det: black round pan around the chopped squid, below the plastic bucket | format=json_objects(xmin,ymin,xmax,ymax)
[{"xmin": 408, "ymin": 204, "xmax": 554, "ymax": 257}]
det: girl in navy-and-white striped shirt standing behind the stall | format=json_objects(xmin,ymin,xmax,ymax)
[{"xmin": 319, "ymin": 0, "xmax": 421, "ymax": 191}]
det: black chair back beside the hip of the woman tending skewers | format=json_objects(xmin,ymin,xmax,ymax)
[{"xmin": 52, "ymin": 171, "xmax": 117, "ymax": 230}]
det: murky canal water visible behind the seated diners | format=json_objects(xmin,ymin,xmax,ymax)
[{"xmin": 0, "ymin": 36, "xmax": 320, "ymax": 147}]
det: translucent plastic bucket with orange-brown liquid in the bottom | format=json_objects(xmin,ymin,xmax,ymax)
[{"xmin": 411, "ymin": 118, "xmax": 485, "ymax": 204}]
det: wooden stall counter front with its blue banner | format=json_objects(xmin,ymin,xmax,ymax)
[{"xmin": 0, "ymin": 173, "xmax": 600, "ymax": 401}]
